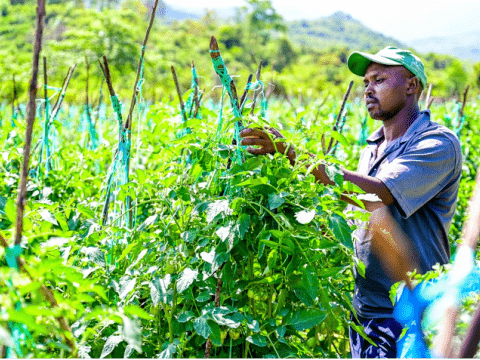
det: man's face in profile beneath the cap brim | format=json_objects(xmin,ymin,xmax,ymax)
[{"xmin": 363, "ymin": 62, "xmax": 412, "ymax": 121}]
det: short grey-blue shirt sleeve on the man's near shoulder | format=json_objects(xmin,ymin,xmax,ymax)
[{"xmin": 375, "ymin": 133, "xmax": 461, "ymax": 218}]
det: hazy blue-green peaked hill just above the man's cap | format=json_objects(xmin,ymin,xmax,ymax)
[{"xmin": 287, "ymin": 12, "xmax": 407, "ymax": 51}]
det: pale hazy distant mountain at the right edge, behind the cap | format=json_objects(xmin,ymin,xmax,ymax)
[{"xmin": 409, "ymin": 31, "xmax": 480, "ymax": 61}]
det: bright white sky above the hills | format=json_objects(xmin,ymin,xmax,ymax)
[{"xmin": 170, "ymin": 0, "xmax": 480, "ymax": 43}]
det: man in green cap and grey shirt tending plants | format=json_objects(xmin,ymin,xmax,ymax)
[{"xmin": 240, "ymin": 47, "xmax": 462, "ymax": 358}]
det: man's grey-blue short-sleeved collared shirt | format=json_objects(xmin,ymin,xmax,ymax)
[{"xmin": 346, "ymin": 110, "xmax": 462, "ymax": 318}]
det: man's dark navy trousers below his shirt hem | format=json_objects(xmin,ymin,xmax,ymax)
[{"xmin": 349, "ymin": 315, "xmax": 402, "ymax": 359}]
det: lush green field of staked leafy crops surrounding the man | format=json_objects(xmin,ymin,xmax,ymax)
[{"xmin": 0, "ymin": 0, "xmax": 480, "ymax": 358}]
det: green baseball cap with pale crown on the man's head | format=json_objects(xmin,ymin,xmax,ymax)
[{"xmin": 347, "ymin": 46, "xmax": 427, "ymax": 88}]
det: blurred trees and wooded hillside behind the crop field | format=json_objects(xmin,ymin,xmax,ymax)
[{"xmin": 0, "ymin": 0, "xmax": 480, "ymax": 107}]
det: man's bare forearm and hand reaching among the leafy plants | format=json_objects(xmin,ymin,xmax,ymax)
[{"xmin": 240, "ymin": 128, "xmax": 394, "ymax": 212}]
